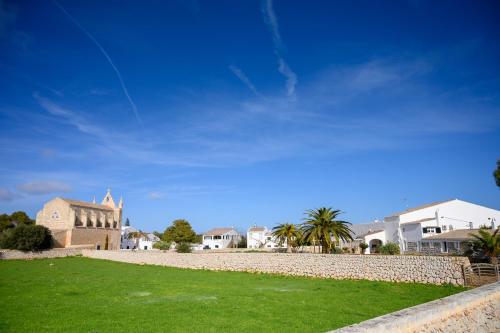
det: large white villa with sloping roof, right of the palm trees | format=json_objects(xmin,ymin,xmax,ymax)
[{"xmin": 351, "ymin": 199, "xmax": 500, "ymax": 253}]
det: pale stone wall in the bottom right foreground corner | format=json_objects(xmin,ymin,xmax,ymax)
[{"xmin": 330, "ymin": 282, "xmax": 500, "ymax": 333}]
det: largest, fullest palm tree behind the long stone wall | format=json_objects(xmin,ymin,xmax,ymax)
[{"xmin": 302, "ymin": 207, "xmax": 352, "ymax": 253}]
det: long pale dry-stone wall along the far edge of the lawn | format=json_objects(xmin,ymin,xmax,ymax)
[{"xmin": 83, "ymin": 250, "xmax": 469, "ymax": 285}]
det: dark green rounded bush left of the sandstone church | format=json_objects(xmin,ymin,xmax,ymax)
[{"xmin": 0, "ymin": 224, "xmax": 54, "ymax": 251}]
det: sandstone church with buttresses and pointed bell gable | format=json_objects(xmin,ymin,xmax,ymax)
[{"xmin": 36, "ymin": 189, "xmax": 123, "ymax": 250}]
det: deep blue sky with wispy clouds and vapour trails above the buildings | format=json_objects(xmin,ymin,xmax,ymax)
[{"xmin": 0, "ymin": 0, "xmax": 500, "ymax": 232}]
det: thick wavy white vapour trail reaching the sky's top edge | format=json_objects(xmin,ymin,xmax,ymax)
[{"xmin": 262, "ymin": 0, "xmax": 298, "ymax": 100}]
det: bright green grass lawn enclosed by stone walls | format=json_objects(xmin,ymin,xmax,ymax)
[{"xmin": 0, "ymin": 257, "xmax": 463, "ymax": 332}]
